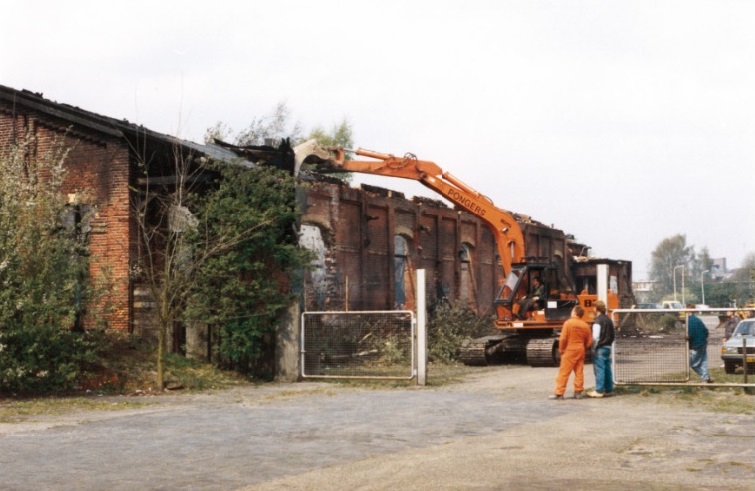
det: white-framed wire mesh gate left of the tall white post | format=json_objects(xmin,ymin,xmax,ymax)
[{"xmin": 301, "ymin": 310, "xmax": 416, "ymax": 380}]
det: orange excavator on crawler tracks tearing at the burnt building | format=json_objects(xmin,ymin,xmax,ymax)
[{"xmin": 297, "ymin": 142, "xmax": 631, "ymax": 366}]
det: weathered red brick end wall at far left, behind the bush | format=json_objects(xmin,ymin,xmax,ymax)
[{"xmin": 0, "ymin": 101, "xmax": 134, "ymax": 330}]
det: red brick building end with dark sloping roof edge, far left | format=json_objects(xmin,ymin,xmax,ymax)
[{"xmin": 0, "ymin": 86, "xmax": 242, "ymax": 331}]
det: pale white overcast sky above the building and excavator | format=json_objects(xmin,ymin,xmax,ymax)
[{"xmin": 0, "ymin": 0, "xmax": 755, "ymax": 280}]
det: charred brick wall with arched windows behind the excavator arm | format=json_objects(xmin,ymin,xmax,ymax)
[{"xmin": 299, "ymin": 182, "xmax": 580, "ymax": 315}]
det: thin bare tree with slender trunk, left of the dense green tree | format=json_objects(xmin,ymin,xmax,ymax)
[{"xmin": 133, "ymin": 145, "xmax": 272, "ymax": 390}]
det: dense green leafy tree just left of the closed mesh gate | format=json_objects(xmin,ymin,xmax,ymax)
[{"xmin": 186, "ymin": 165, "xmax": 311, "ymax": 372}]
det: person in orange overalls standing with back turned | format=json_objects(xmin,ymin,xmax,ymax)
[{"xmin": 548, "ymin": 305, "xmax": 592, "ymax": 399}]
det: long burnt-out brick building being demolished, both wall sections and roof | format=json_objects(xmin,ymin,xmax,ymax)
[{"xmin": 0, "ymin": 86, "xmax": 631, "ymax": 376}]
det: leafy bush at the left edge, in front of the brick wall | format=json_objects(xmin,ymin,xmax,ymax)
[{"xmin": 0, "ymin": 137, "xmax": 103, "ymax": 392}]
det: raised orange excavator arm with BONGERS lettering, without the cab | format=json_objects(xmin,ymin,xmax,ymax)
[{"xmin": 308, "ymin": 147, "xmax": 525, "ymax": 275}]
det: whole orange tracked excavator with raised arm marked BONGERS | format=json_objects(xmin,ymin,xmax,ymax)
[{"xmin": 294, "ymin": 140, "xmax": 632, "ymax": 366}]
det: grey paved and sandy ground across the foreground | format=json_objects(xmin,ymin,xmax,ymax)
[{"xmin": 0, "ymin": 354, "xmax": 755, "ymax": 490}]
